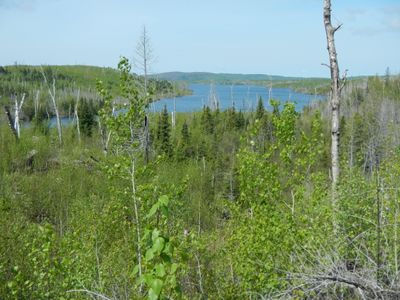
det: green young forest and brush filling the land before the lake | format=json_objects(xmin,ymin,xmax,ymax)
[{"xmin": 0, "ymin": 52, "xmax": 400, "ymax": 299}]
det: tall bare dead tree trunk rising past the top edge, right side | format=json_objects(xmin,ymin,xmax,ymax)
[{"xmin": 323, "ymin": 0, "xmax": 345, "ymax": 195}]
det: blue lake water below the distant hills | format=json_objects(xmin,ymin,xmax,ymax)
[{"xmin": 150, "ymin": 84, "xmax": 325, "ymax": 112}]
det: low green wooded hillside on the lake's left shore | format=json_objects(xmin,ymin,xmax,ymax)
[{"xmin": 0, "ymin": 65, "xmax": 190, "ymax": 121}]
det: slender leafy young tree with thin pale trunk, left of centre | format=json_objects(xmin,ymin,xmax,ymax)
[{"xmin": 97, "ymin": 57, "xmax": 145, "ymax": 293}]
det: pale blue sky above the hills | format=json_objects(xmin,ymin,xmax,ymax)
[{"xmin": 0, "ymin": 0, "xmax": 400, "ymax": 77}]
